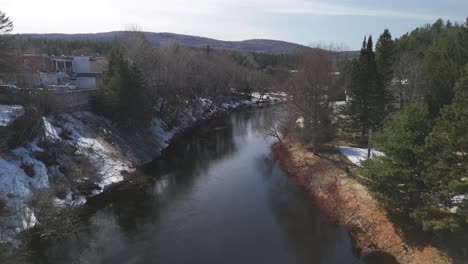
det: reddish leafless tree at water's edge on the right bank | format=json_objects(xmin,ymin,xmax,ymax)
[{"xmin": 288, "ymin": 45, "xmax": 338, "ymax": 154}]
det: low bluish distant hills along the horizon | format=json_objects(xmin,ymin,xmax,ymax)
[{"xmin": 18, "ymin": 31, "xmax": 307, "ymax": 54}]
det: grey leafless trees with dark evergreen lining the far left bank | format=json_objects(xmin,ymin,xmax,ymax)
[{"xmin": 94, "ymin": 31, "xmax": 288, "ymax": 127}]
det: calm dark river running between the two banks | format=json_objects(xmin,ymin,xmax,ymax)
[{"xmin": 37, "ymin": 109, "xmax": 361, "ymax": 264}]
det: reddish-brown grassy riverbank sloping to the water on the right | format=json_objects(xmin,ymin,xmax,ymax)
[{"xmin": 273, "ymin": 139, "xmax": 453, "ymax": 264}]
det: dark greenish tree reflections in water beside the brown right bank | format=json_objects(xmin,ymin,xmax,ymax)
[{"xmin": 257, "ymin": 156, "xmax": 359, "ymax": 263}]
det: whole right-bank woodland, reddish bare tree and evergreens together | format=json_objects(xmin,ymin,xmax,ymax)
[{"xmin": 286, "ymin": 20, "xmax": 468, "ymax": 236}]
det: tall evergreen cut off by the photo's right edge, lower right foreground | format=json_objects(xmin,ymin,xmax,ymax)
[{"xmin": 413, "ymin": 64, "xmax": 468, "ymax": 231}]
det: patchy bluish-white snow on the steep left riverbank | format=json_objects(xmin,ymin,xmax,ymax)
[{"xmin": 0, "ymin": 112, "xmax": 132, "ymax": 244}]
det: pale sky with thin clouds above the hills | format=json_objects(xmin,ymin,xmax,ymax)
[{"xmin": 0, "ymin": 0, "xmax": 468, "ymax": 49}]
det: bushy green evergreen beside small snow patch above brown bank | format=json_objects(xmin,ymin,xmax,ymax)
[{"xmin": 362, "ymin": 104, "xmax": 431, "ymax": 216}]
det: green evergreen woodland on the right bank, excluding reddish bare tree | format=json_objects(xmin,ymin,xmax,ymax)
[{"xmin": 348, "ymin": 20, "xmax": 468, "ymax": 234}]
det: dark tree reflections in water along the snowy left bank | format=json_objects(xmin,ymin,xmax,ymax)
[{"xmin": 39, "ymin": 106, "xmax": 286, "ymax": 264}]
